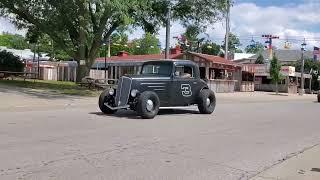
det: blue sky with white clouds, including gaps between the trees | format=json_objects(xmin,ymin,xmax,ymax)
[{"xmin": 0, "ymin": 0, "xmax": 320, "ymax": 50}]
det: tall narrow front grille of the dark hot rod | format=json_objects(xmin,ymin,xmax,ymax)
[{"xmin": 115, "ymin": 76, "xmax": 132, "ymax": 106}]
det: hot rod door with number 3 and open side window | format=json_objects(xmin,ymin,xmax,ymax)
[{"xmin": 170, "ymin": 65, "xmax": 198, "ymax": 106}]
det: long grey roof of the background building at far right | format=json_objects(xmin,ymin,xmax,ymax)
[{"xmin": 252, "ymin": 49, "xmax": 313, "ymax": 62}]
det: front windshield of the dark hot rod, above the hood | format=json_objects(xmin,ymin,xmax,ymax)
[{"xmin": 141, "ymin": 63, "xmax": 172, "ymax": 76}]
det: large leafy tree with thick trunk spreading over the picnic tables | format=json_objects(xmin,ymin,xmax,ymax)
[{"xmin": 0, "ymin": 0, "xmax": 226, "ymax": 81}]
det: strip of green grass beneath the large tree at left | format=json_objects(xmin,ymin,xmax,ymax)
[{"xmin": 0, "ymin": 80, "xmax": 99, "ymax": 96}]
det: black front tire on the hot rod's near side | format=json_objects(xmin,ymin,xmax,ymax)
[{"xmin": 136, "ymin": 91, "xmax": 160, "ymax": 119}]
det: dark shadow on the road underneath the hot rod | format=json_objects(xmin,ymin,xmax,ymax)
[{"xmin": 89, "ymin": 109, "xmax": 199, "ymax": 119}]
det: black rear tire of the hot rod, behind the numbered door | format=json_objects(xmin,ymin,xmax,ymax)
[{"xmin": 198, "ymin": 89, "xmax": 216, "ymax": 114}]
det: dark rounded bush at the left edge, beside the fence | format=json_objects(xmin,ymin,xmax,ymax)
[{"xmin": 0, "ymin": 51, "xmax": 24, "ymax": 72}]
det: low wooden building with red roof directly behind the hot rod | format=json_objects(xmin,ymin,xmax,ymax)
[{"xmin": 90, "ymin": 47, "xmax": 254, "ymax": 92}]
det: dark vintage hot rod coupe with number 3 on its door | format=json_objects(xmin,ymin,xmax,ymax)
[{"xmin": 99, "ymin": 60, "xmax": 216, "ymax": 119}]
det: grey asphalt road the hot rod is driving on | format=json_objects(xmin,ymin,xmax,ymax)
[{"xmin": 0, "ymin": 89, "xmax": 320, "ymax": 180}]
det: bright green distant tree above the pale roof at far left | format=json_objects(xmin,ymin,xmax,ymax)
[{"xmin": 0, "ymin": 33, "xmax": 29, "ymax": 49}]
